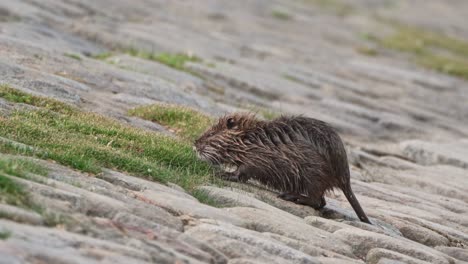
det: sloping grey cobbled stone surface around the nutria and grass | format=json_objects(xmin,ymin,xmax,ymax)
[{"xmin": 0, "ymin": 0, "xmax": 468, "ymax": 264}]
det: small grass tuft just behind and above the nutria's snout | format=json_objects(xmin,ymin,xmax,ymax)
[{"xmin": 129, "ymin": 104, "xmax": 213, "ymax": 142}]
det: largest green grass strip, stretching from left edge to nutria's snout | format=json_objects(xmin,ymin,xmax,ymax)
[{"xmin": 0, "ymin": 87, "xmax": 212, "ymax": 190}]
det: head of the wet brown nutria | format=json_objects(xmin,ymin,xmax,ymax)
[{"xmin": 194, "ymin": 113, "xmax": 262, "ymax": 165}]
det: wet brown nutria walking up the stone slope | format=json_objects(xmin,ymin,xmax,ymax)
[{"xmin": 195, "ymin": 114, "xmax": 371, "ymax": 224}]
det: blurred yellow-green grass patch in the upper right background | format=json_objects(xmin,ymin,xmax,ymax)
[{"xmin": 368, "ymin": 25, "xmax": 468, "ymax": 79}]
